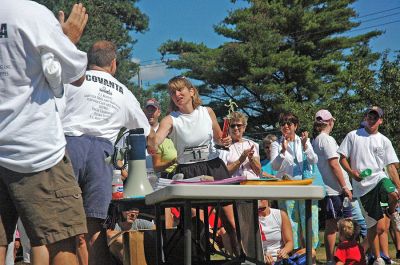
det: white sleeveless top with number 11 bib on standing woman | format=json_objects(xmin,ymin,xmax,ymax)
[{"xmin": 170, "ymin": 106, "xmax": 219, "ymax": 164}]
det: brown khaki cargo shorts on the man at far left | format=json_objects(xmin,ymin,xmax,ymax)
[{"xmin": 0, "ymin": 155, "xmax": 87, "ymax": 246}]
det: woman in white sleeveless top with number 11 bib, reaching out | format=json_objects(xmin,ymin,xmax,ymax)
[{"xmin": 152, "ymin": 76, "xmax": 239, "ymax": 254}]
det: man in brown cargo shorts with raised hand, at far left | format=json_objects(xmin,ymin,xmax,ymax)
[{"xmin": 0, "ymin": 0, "xmax": 88, "ymax": 264}]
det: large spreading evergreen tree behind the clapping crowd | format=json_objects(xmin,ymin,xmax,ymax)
[{"xmin": 159, "ymin": 0, "xmax": 380, "ymax": 139}]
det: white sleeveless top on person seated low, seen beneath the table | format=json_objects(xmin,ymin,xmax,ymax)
[{"xmin": 258, "ymin": 208, "xmax": 283, "ymax": 259}]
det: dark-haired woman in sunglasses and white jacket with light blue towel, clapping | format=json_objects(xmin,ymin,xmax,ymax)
[{"xmin": 271, "ymin": 112, "xmax": 319, "ymax": 252}]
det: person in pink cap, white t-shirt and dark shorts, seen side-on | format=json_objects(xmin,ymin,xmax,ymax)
[{"xmin": 312, "ymin": 109, "xmax": 352, "ymax": 264}]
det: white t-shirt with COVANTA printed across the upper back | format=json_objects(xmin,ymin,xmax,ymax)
[{"xmin": 59, "ymin": 70, "xmax": 150, "ymax": 144}]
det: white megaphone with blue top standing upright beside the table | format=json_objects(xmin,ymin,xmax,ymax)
[{"xmin": 124, "ymin": 128, "xmax": 153, "ymax": 198}]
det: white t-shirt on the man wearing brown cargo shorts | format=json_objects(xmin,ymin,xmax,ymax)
[{"xmin": 0, "ymin": 0, "xmax": 87, "ymax": 173}]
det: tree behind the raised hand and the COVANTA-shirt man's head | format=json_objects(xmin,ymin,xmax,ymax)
[{"xmin": 36, "ymin": 0, "xmax": 149, "ymax": 97}]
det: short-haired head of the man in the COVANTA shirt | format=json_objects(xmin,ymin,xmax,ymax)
[{"xmin": 87, "ymin": 40, "xmax": 117, "ymax": 68}]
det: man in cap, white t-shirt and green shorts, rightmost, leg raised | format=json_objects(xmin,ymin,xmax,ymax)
[{"xmin": 338, "ymin": 107, "xmax": 400, "ymax": 264}]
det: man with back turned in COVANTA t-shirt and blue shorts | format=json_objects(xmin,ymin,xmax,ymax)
[{"xmin": 62, "ymin": 40, "xmax": 155, "ymax": 265}]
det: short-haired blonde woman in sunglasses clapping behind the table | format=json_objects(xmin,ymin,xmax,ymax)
[{"xmin": 222, "ymin": 111, "xmax": 261, "ymax": 178}]
